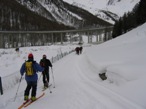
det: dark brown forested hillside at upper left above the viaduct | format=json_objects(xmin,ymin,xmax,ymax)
[{"xmin": 0, "ymin": 0, "xmax": 71, "ymax": 30}]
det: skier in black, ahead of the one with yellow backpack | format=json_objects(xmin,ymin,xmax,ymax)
[{"xmin": 40, "ymin": 55, "xmax": 52, "ymax": 88}]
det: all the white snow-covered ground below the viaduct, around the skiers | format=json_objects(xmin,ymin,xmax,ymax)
[{"xmin": 0, "ymin": 24, "xmax": 146, "ymax": 109}]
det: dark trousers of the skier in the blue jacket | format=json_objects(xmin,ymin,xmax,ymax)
[{"xmin": 24, "ymin": 81, "xmax": 37, "ymax": 96}]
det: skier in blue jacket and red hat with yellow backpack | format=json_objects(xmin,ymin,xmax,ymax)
[{"xmin": 20, "ymin": 53, "xmax": 44, "ymax": 101}]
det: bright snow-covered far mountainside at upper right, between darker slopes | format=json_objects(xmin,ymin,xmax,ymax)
[{"xmin": 63, "ymin": 0, "xmax": 140, "ymax": 23}]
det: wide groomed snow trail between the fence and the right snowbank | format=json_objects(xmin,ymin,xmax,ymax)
[{"xmin": 2, "ymin": 51, "xmax": 142, "ymax": 109}]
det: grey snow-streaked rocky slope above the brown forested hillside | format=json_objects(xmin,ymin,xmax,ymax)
[{"xmin": 17, "ymin": 0, "xmax": 82, "ymax": 27}]
